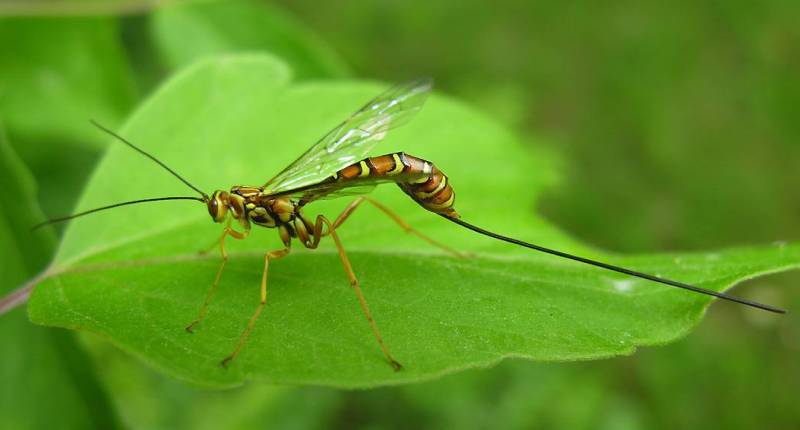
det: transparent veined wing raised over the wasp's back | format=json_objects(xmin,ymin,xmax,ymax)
[{"xmin": 264, "ymin": 78, "xmax": 433, "ymax": 194}]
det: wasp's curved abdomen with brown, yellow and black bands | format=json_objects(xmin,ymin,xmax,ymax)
[{"xmin": 335, "ymin": 152, "xmax": 458, "ymax": 218}]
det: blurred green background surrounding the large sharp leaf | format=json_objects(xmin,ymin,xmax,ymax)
[{"xmin": 0, "ymin": 0, "xmax": 800, "ymax": 429}]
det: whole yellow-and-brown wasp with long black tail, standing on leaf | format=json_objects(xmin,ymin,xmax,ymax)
[{"xmin": 37, "ymin": 79, "xmax": 784, "ymax": 370}]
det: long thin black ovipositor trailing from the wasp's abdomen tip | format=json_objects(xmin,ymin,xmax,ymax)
[{"xmin": 439, "ymin": 214, "xmax": 786, "ymax": 314}]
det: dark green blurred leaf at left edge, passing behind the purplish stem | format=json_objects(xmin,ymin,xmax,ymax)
[{"xmin": 0, "ymin": 130, "xmax": 120, "ymax": 429}]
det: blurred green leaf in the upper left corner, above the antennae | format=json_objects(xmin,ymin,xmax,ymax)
[{"xmin": 0, "ymin": 18, "xmax": 135, "ymax": 149}]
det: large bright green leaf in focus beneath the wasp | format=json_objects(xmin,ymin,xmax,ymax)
[{"xmin": 29, "ymin": 56, "xmax": 800, "ymax": 387}]
